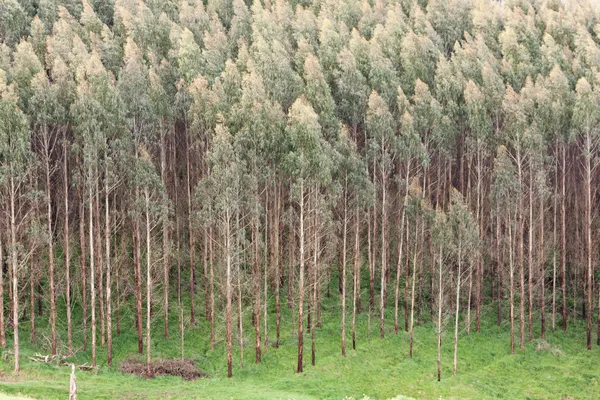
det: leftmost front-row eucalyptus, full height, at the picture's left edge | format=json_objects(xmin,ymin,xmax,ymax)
[{"xmin": 0, "ymin": 70, "xmax": 32, "ymax": 374}]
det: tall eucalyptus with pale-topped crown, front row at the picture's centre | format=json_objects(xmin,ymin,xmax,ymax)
[{"xmin": 285, "ymin": 97, "xmax": 330, "ymax": 373}]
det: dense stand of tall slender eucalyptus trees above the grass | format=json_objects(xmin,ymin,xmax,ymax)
[{"xmin": 0, "ymin": 0, "xmax": 600, "ymax": 386}]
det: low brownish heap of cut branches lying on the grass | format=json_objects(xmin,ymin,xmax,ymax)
[{"xmin": 121, "ymin": 357, "xmax": 209, "ymax": 381}]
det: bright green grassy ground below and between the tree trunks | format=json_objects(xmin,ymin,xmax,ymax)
[{"xmin": 0, "ymin": 295, "xmax": 600, "ymax": 399}]
